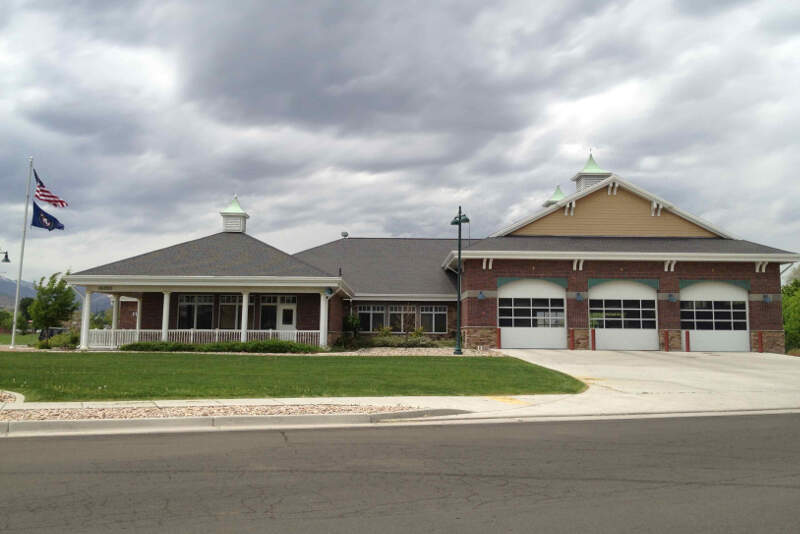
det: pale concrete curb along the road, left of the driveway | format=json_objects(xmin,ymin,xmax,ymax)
[{"xmin": 0, "ymin": 409, "xmax": 470, "ymax": 438}]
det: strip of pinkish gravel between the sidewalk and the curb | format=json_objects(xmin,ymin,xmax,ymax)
[{"xmin": 0, "ymin": 404, "xmax": 415, "ymax": 421}]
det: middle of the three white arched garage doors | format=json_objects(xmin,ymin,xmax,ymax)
[{"xmin": 589, "ymin": 280, "xmax": 658, "ymax": 350}]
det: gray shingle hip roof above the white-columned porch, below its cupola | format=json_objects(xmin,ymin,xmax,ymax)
[{"xmin": 75, "ymin": 232, "xmax": 335, "ymax": 276}]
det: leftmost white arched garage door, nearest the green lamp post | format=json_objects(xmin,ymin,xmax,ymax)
[{"xmin": 497, "ymin": 279, "xmax": 567, "ymax": 349}]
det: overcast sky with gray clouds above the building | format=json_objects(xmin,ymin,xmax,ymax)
[{"xmin": 0, "ymin": 0, "xmax": 800, "ymax": 279}]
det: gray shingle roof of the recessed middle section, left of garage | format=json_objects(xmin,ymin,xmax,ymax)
[{"xmin": 295, "ymin": 237, "xmax": 457, "ymax": 295}]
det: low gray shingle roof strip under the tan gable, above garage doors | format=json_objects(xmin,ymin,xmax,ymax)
[{"xmin": 462, "ymin": 236, "xmax": 792, "ymax": 254}]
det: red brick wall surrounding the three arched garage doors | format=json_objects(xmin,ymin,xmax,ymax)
[{"xmin": 462, "ymin": 260, "xmax": 783, "ymax": 330}]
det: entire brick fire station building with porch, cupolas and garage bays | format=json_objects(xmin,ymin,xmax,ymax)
[{"xmin": 68, "ymin": 156, "xmax": 800, "ymax": 352}]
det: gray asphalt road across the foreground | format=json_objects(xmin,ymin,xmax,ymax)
[{"xmin": 0, "ymin": 415, "xmax": 800, "ymax": 534}]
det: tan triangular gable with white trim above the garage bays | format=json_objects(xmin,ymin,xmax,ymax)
[{"xmin": 491, "ymin": 175, "xmax": 733, "ymax": 239}]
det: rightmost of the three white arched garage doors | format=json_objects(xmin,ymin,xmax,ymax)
[{"xmin": 681, "ymin": 282, "xmax": 750, "ymax": 352}]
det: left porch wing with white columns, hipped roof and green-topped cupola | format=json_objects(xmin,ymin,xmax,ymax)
[{"xmin": 65, "ymin": 197, "xmax": 353, "ymax": 350}]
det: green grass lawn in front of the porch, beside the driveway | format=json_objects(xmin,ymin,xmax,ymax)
[{"xmin": 0, "ymin": 352, "xmax": 585, "ymax": 401}]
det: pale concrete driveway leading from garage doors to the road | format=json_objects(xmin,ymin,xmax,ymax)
[{"xmin": 472, "ymin": 349, "xmax": 800, "ymax": 417}]
